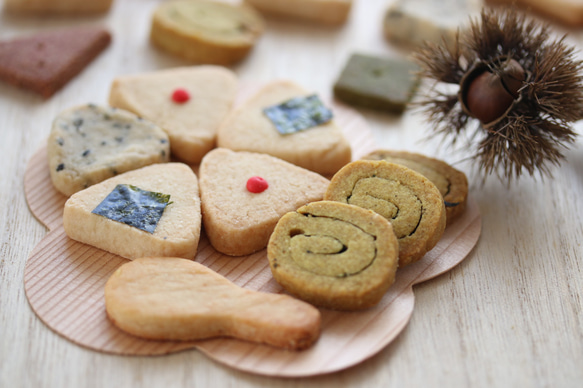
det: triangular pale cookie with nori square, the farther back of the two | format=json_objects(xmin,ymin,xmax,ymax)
[{"xmin": 217, "ymin": 81, "xmax": 352, "ymax": 175}]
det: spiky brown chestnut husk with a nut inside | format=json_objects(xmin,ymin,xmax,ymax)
[{"xmin": 415, "ymin": 9, "xmax": 583, "ymax": 183}]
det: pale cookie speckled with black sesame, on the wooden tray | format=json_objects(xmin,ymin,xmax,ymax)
[{"xmin": 47, "ymin": 104, "xmax": 170, "ymax": 196}]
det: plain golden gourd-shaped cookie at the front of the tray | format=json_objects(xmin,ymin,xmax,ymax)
[{"xmin": 105, "ymin": 257, "xmax": 320, "ymax": 350}]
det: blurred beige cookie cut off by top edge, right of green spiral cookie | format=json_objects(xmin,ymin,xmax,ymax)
[{"xmin": 245, "ymin": 0, "xmax": 352, "ymax": 24}]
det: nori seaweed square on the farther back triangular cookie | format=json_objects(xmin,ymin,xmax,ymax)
[{"xmin": 263, "ymin": 94, "xmax": 332, "ymax": 135}]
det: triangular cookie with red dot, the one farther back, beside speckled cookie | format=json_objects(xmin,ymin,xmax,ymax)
[{"xmin": 109, "ymin": 66, "xmax": 237, "ymax": 164}]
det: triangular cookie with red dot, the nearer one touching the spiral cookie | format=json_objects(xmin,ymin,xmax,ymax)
[{"xmin": 199, "ymin": 148, "xmax": 329, "ymax": 256}]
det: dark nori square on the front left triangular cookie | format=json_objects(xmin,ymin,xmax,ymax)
[{"xmin": 92, "ymin": 184, "xmax": 170, "ymax": 233}]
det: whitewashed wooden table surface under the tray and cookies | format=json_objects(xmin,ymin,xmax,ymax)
[{"xmin": 0, "ymin": 0, "xmax": 583, "ymax": 388}]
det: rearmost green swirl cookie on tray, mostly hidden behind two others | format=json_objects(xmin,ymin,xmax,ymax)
[{"xmin": 362, "ymin": 150, "xmax": 468, "ymax": 224}]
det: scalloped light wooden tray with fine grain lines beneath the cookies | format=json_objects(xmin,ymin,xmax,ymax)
[{"xmin": 24, "ymin": 102, "xmax": 481, "ymax": 377}]
